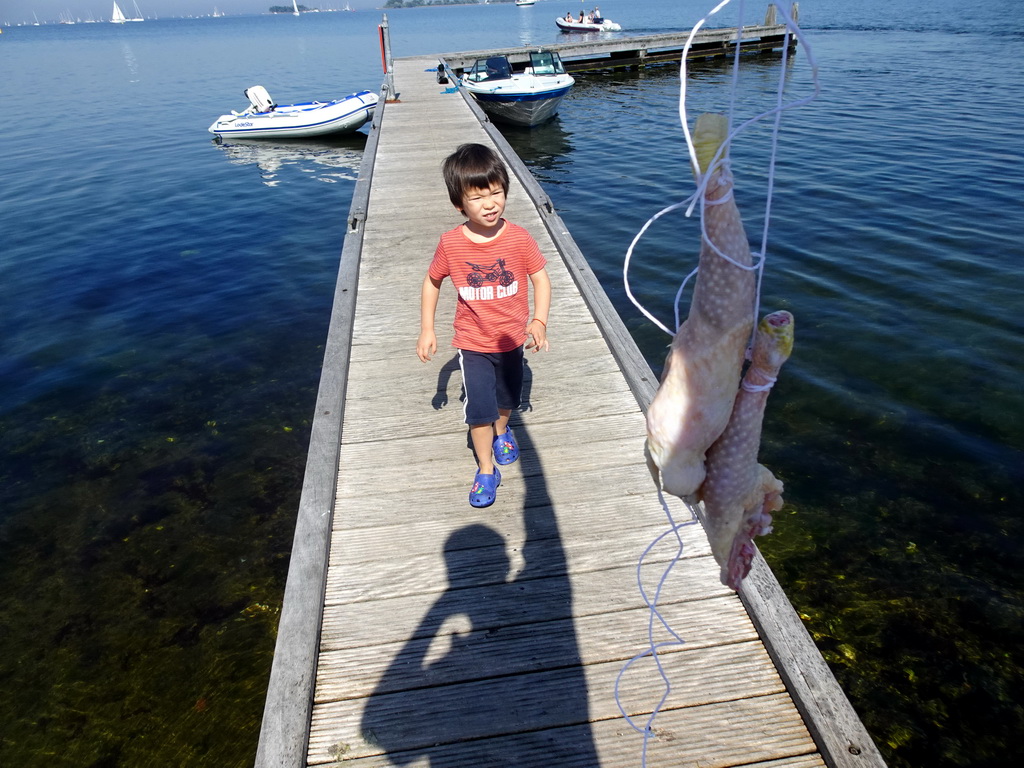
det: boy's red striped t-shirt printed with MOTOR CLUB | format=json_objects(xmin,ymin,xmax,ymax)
[{"xmin": 427, "ymin": 220, "xmax": 548, "ymax": 352}]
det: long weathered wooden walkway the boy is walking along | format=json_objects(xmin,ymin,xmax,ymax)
[{"xmin": 256, "ymin": 46, "xmax": 884, "ymax": 768}]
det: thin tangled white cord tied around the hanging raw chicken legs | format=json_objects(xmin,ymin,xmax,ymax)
[{"xmin": 614, "ymin": 0, "xmax": 820, "ymax": 768}]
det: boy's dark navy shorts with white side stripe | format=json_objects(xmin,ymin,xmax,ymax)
[{"xmin": 459, "ymin": 346, "xmax": 522, "ymax": 425}]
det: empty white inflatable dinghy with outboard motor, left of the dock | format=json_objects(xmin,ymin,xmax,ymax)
[{"xmin": 210, "ymin": 85, "xmax": 378, "ymax": 138}]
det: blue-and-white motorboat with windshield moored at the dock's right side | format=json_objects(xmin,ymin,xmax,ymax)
[{"xmin": 462, "ymin": 51, "xmax": 575, "ymax": 126}]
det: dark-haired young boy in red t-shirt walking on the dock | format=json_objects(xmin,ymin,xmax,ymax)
[{"xmin": 416, "ymin": 144, "xmax": 551, "ymax": 507}]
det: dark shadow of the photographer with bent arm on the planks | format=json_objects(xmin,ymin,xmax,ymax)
[{"xmin": 361, "ymin": 415, "xmax": 598, "ymax": 768}]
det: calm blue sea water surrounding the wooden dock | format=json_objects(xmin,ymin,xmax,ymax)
[{"xmin": 0, "ymin": 0, "xmax": 1024, "ymax": 767}]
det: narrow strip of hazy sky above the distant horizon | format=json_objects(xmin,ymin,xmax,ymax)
[{"xmin": 0, "ymin": 0, "xmax": 385, "ymax": 25}]
